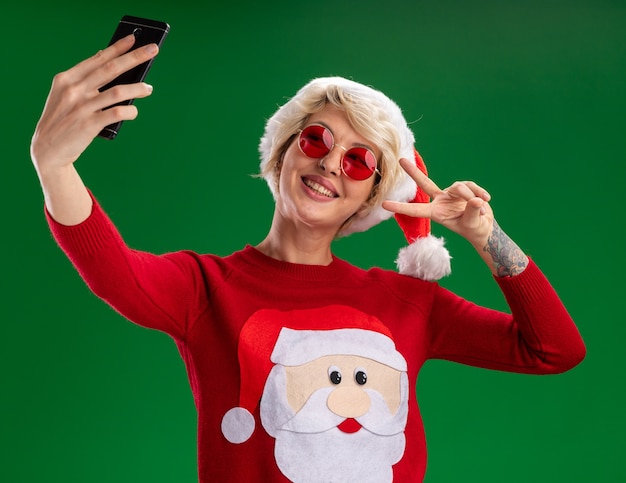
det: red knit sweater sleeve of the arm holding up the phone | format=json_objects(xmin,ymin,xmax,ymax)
[{"xmin": 46, "ymin": 193, "xmax": 208, "ymax": 340}]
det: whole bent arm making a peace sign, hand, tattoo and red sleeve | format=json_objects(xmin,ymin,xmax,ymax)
[{"xmin": 383, "ymin": 160, "xmax": 585, "ymax": 374}]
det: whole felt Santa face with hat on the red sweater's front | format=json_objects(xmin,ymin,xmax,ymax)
[{"xmin": 222, "ymin": 305, "xmax": 409, "ymax": 483}]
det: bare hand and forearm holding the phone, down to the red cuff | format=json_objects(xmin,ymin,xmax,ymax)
[{"xmin": 30, "ymin": 35, "xmax": 158, "ymax": 226}]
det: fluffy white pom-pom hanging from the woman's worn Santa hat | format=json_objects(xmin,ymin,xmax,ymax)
[{"xmin": 396, "ymin": 235, "xmax": 451, "ymax": 282}]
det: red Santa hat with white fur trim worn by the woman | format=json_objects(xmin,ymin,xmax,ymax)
[{"xmin": 259, "ymin": 77, "xmax": 450, "ymax": 281}]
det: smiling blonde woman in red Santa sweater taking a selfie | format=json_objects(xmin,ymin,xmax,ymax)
[{"xmin": 31, "ymin": 36, "xmax": 585, "ymax": 483}]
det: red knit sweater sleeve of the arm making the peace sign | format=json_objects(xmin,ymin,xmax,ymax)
[{"xmin": 429, "ymin": 261, "xmax": 586, "ymax": 374}]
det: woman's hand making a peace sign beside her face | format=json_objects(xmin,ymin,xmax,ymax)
[{"xmin": 382, "ymin": 158, "xmax": 494, "ymax": 248}]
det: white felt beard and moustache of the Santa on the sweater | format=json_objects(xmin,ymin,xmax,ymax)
[{"xmin": 261, "ymin": 365, "xmax": 408, "ymax": 483}]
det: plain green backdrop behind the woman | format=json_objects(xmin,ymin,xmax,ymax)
[{"xmin": 0, "ymin": 0, "xmax": 626, "ymax": 483}]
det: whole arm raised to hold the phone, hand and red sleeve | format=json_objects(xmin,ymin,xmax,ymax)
[{"xmin": 31, "ymin": 35, "xmax": 207, "ymax": 339}]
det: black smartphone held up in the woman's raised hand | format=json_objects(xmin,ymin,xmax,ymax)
[{"xmin": 98, "ymin": 15, "xmax": 170, "ymax": 139}]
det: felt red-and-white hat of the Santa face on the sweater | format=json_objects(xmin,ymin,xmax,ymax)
[{"xmin": 222, "ymin": 305, "xmax": 407, "ymax": 444}]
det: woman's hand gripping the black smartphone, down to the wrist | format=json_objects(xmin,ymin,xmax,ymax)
[{"xmin": 31, "ymin": 16, "xmax": 164, "ymax": 179}]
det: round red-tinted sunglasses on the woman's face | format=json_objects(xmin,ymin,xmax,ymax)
[{"xmin": 298, "ymin": 124, "xmax": 380, "ymax": 181}]
